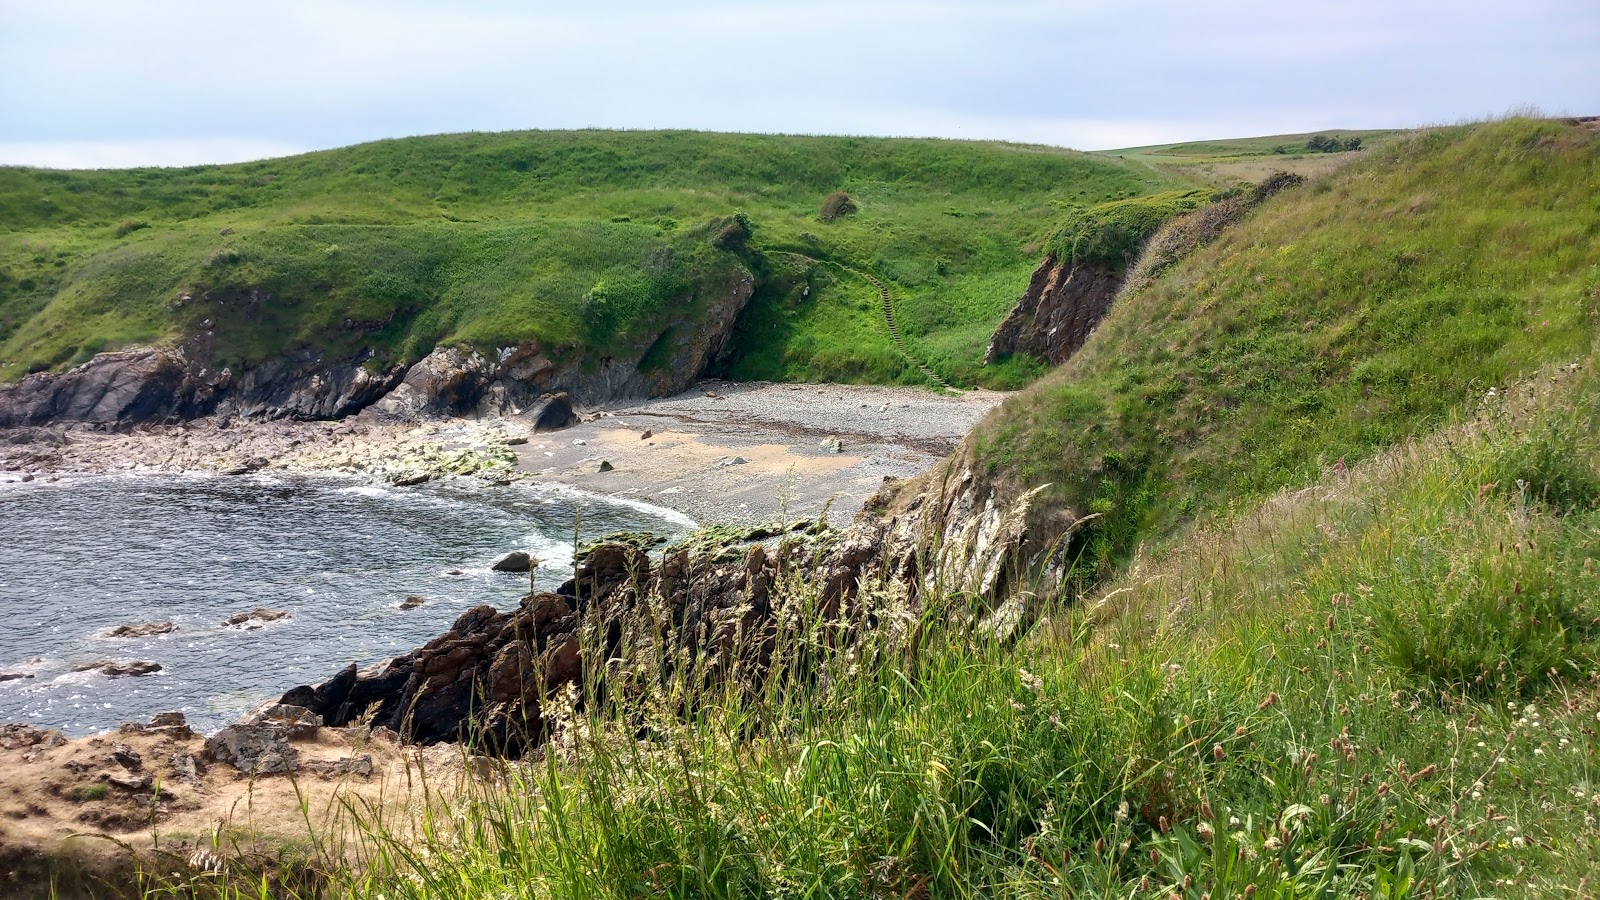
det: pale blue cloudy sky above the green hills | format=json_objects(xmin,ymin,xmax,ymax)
[{"xmin": 0, "ymin": 0, "xmax": 1600, "ymax": 168}]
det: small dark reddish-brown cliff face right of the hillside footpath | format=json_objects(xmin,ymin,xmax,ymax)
[{"xmin": 984, "ymin": 255, "xmax": 1125, "ymax": 365}]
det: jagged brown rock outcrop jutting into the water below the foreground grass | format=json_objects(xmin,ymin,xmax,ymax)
[{"xmin": 280, "ymin": 445, "xmax": 1083, "ymax": 756}]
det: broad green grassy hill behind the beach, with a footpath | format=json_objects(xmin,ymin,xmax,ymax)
[{"xmin": 0, "ymin": 131, "xmax": 1173, "ymax": 381}]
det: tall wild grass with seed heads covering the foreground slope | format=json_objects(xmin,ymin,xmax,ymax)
[{"xmin": 155, "ymin": 356, "xmax": 1600, "ymax": 900}]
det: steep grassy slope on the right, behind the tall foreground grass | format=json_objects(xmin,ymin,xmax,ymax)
[{"xmin": 976, "ymin": 120, "xmax": 1600, "ymax": 570}]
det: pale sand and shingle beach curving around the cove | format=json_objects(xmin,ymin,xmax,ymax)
[{"xmin": 0, "ymin": 381, "xmax": 1005, "ymax": 524}]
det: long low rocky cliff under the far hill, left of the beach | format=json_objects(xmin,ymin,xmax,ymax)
[{"xmin": 0, "ymin": 272, "xmax": 755, "ymax": 428}]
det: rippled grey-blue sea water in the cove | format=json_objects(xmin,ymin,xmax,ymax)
[{"xmin": 0, "ymin": 476, "xmax": 691, "ymax": 735}]
